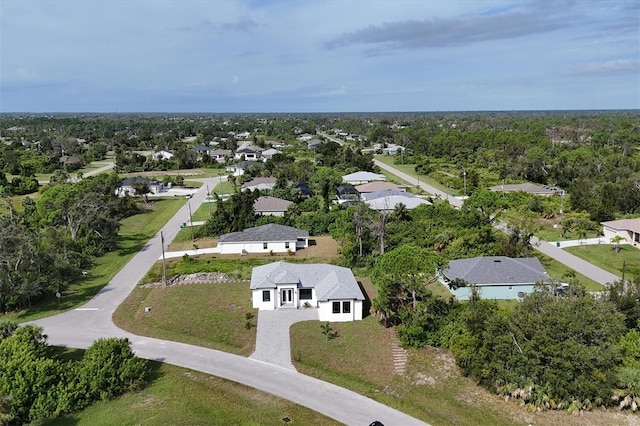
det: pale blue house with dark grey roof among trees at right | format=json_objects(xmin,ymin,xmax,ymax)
[{"xmin": 438, "ymin": 256, "xmax": 549, "ymax": 300}]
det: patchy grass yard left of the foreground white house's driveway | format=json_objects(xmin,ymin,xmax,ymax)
[{"xmin": 113, "ymin": 281, "xmax": 257, "ymax": 356}]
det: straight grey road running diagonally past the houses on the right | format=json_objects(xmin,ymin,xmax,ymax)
[{"xmin": 373, "ymin": 159, "xmax": 620, "ymax": 286}]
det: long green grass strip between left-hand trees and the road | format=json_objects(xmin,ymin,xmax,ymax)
[{"xmin": 5, "ymin": 197, "xmax": 185, "ymax": 322}]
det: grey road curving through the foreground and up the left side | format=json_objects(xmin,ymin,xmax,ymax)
[{"xmin": 34, "ymin": 179, "xmax": 424, "ymax": 425}]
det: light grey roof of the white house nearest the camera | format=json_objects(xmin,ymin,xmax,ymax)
[{"xmin": 249, "ymin": 261, "xmax": 364, "ymax": 301}]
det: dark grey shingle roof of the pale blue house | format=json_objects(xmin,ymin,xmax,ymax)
[{"xmin": 443, "ymin": 256, "xmax": 549, "ymax": 286}]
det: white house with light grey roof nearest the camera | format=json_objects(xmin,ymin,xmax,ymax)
[{"xmin": 249, "ymin": 262, "xmax": 365, "ymax": 322}]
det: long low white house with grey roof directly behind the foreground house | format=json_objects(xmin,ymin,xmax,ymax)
[{"xmin": 217, "ymin": 223, "xmax": 309, "ymax": 254}]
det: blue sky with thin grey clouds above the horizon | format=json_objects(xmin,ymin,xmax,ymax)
[{"xmin": 0, "ymin": 0, "xmax": 640, "ymax": 112}]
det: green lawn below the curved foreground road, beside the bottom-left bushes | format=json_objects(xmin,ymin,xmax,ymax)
[{"xmin": 45, "ymin": 362, "xmax": 339, "ymax": 426}]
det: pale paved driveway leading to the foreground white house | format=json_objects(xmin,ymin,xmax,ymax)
[{"xmin": 250, "ymin": 309, "xmax": 320, "ymax": 371}]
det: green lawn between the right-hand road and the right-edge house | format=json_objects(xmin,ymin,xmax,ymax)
[{"xmin": 564, "ymin": 244, "xmax": 640, "ymax": 278}]
